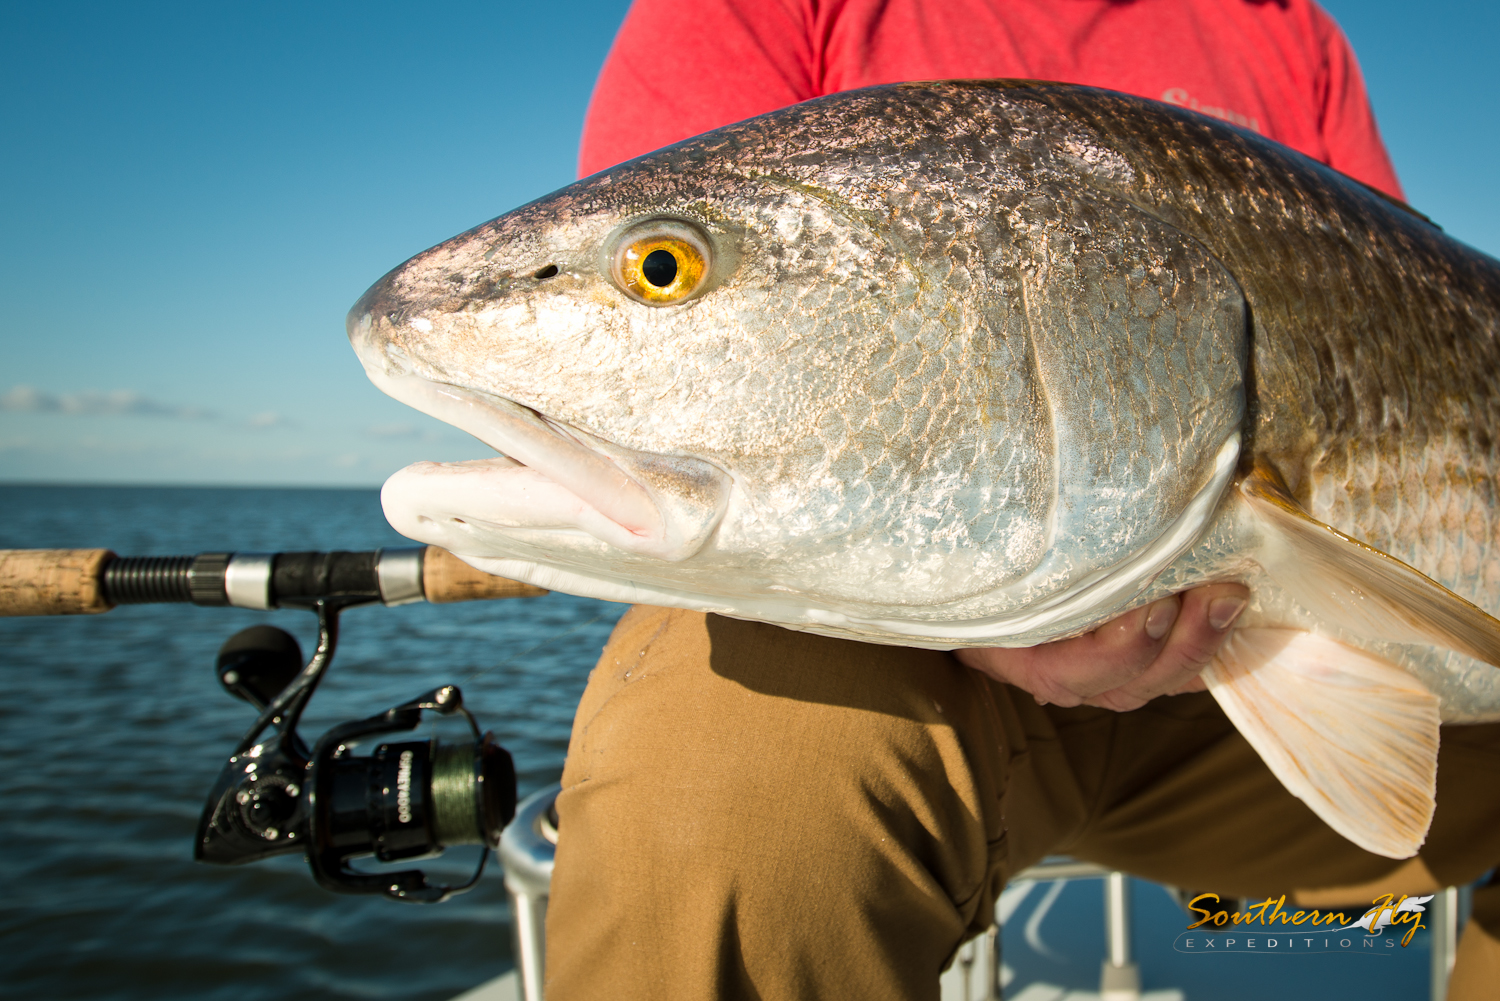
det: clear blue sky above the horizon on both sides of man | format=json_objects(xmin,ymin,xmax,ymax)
[{"xmin": 0, "ymin": 0, "xmax": 1500, "ymax": 486}]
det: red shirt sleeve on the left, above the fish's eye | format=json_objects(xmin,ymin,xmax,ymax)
[{"xmin": 579, "ymin": 0, "xmax": 818, "ymax": 176}]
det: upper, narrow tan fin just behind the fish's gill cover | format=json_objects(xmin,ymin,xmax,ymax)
[{"xmin": 1239, "ymin": 468, "xmax": 1500, "ymax": 668}]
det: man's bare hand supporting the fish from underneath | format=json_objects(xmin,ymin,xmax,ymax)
[{"xmin": 953, "ymin": 584, "xmax": 1250, "ymax": 713}]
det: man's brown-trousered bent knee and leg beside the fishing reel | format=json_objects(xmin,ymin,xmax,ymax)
[{"xmin": 549, "ymin": 612, "xmax": 1002, "ymax": 989}]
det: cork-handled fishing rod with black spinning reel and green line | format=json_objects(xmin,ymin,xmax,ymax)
[{"xmin": 0, "ymin": 546, "xmax": 546, "ymax": 903}]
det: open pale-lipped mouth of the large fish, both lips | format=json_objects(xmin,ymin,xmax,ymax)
[{"xmin": 362, "ymin": 360, "xmax": 734, "ymax": 561}]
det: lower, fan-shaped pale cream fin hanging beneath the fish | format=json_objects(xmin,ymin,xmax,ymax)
[{"xmin": 1203, "ymin": 629, "xmax": 1440, "ymax": 858}]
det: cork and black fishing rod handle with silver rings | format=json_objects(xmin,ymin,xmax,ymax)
[{"xmin": 0, "ymin": 546, "xmax": 546, "ymax": 615}]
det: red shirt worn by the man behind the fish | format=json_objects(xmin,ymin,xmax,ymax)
[{"xmin": 579, "ymin": 0, "xmax": 1401, "ymax": 197}]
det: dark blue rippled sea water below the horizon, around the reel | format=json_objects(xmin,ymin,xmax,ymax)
[{"xmin": 0, "ymin": 486, "xmax": 1430, "ymax": 1001}]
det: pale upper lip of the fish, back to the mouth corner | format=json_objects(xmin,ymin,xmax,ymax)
[{"xmin": 351, "ymin": 353, "xmax": 732, "ymax": 561}]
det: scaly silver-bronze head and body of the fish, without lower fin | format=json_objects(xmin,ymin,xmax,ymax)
[{"xmin": 350, "ymin": 81, "xmax": 1500, "ymax": 720}]
